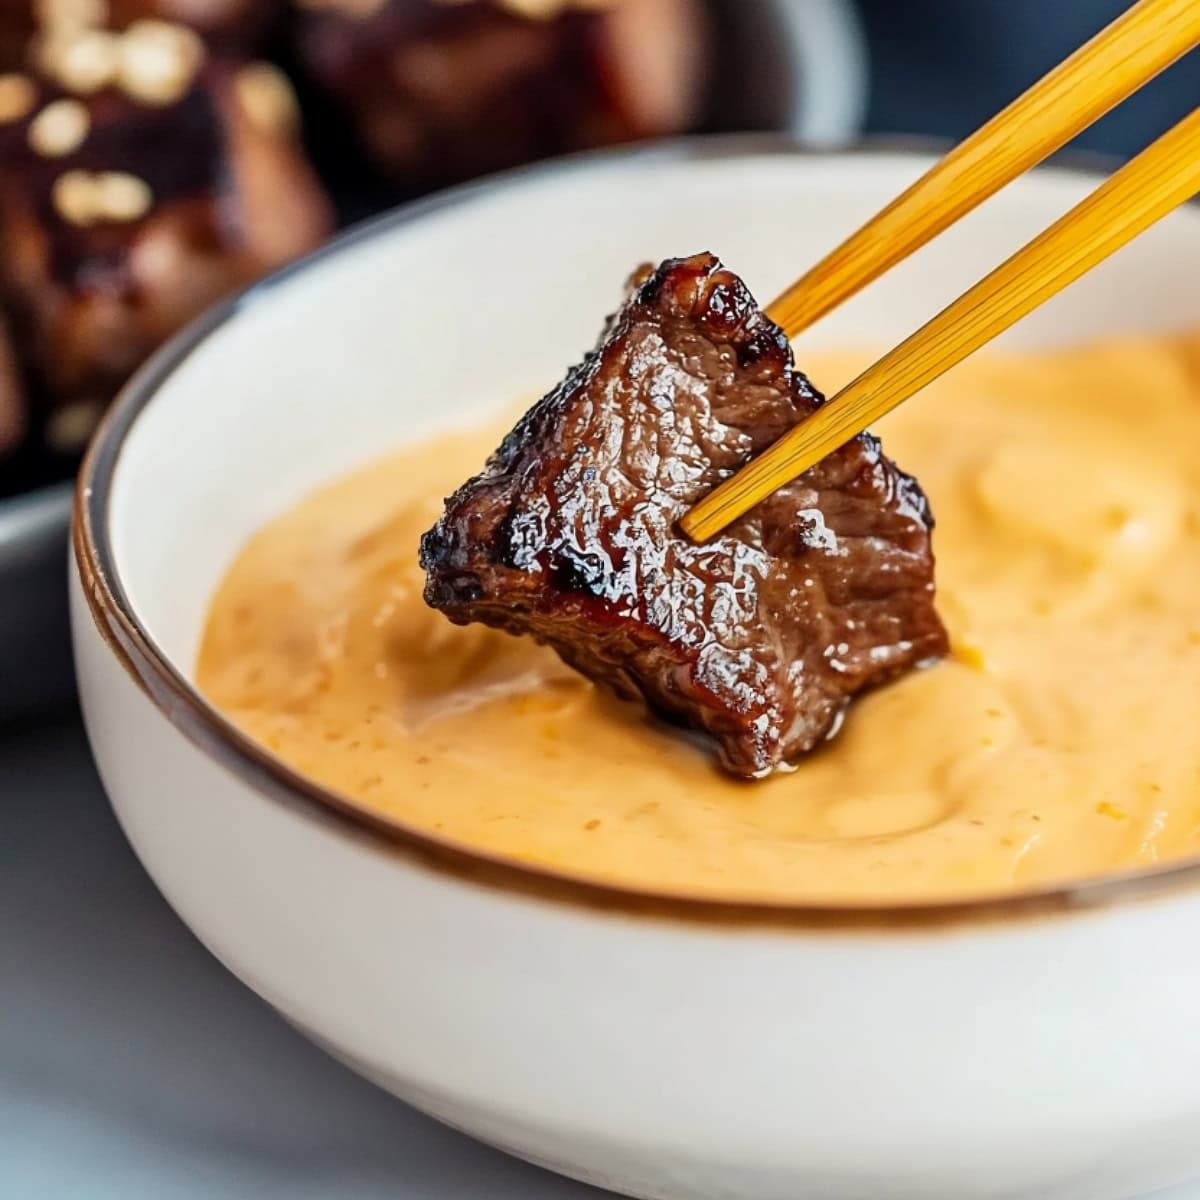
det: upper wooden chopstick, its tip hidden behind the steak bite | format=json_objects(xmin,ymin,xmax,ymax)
[{"xmin": 767, "ymin": 0, "xmax": 1200, "ymax": 337}]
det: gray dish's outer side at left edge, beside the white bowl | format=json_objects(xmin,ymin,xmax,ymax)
[{"xmin": 0, "ymin": 484, "xmax": 74, "ymax": 724}]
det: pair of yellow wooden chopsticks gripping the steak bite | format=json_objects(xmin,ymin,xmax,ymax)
[{"xmin": 680, "ymin": 0, "xmax": 1200, "ymax": 541}]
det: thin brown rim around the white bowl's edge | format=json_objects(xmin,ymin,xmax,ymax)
[{"xmin": 73, "ymin": 134, "xmax": 1200, "ymax": 931}]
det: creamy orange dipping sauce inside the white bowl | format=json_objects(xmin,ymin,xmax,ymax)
[{"xmin": 198, "ymin": 340, "xmax": 1200, "ymax": 901}]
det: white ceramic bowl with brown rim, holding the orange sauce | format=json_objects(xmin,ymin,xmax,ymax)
[{"xmin": 73, "ymin": 139, "xmax": 1200, "ymax": 1200}]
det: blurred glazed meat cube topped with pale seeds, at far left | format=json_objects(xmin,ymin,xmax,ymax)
[{"xmin": 0, "ymin": 23, "xmax": 331, "ymax": 455}]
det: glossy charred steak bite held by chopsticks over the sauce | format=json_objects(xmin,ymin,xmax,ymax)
[{"xmin": 421, "ymin": 254, "xmax": 947, "ymax": 776}]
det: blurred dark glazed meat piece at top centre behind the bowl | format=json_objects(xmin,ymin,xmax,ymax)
[{"xmin": 295, "ymin": 0, "xmax": 707, "ymax": 194}]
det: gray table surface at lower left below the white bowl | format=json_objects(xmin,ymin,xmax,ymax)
[{"xmin": 0, "ymin": 713, "xmax": 600, "ymax": 1200}]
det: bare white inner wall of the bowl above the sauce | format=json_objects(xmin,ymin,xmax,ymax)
[{"xmin": 109, "ymin": 145, "xmax": 1200, "ymax": 677}]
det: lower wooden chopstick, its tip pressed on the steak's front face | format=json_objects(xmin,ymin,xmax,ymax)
[{"xmin": 680, "ymin": 108, "xmax": 1200, "ymax": 541}]
